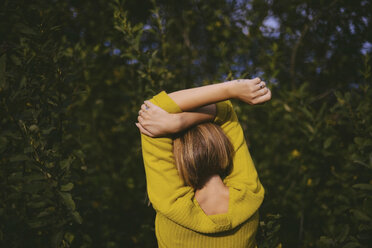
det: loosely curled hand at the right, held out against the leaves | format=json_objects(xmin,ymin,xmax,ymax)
[{"xmin": 228, "ymin": 78, "xmax": 271, "ymax": 105}]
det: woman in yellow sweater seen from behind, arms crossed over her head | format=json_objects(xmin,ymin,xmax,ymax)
[{"xmin": 136, "ymin": 78, "xmax": 271, "ymax": 248}]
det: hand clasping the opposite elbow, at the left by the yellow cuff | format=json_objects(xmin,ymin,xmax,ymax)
[{"xmin": 136, "ymin": 101, "xmax": 180, "ymax": 137}]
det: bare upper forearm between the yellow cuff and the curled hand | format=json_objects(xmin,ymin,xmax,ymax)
[{"xmin": 168, "ymin": 81, "xmax": 234, "ymax": 111}]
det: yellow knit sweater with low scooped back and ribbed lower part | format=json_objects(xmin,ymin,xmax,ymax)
[{"xmin": 141, "ymin": 91, "xmax": 264, "ymax": 248}]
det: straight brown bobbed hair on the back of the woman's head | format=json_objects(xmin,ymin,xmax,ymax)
[{"xmin": 173, "ymin": 122, "xmax": 234, "ymax": 189}]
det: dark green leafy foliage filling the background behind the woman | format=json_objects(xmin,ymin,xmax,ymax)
[{"xmin": 0, "ymin": 0, "xmax": 372, "ymax": 248}]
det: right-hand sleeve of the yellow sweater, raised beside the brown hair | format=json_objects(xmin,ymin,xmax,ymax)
[{"xmin": 214, "ymin": 100, "xmax": 264, "ymax": 226}]
